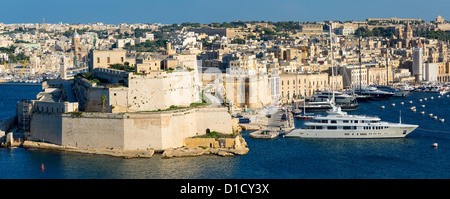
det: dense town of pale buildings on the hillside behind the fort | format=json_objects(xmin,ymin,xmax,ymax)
[{"xmin": 0, "ymin": 16, "xmax": 450, "ymax": 102}]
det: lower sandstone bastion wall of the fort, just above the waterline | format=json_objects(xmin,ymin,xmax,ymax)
[{"xmin": 28, "ymin": 107, "xmax": 233, "ymax": 150}]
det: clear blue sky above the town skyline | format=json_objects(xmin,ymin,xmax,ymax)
[{"xmin": 0, "ymin": 0, "xmax": 450, "ymax": 24}]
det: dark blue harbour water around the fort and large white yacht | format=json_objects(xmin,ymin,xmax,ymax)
[{"xmin": 0, "ymin": 85, "xmax": 450, "ymax": 179}]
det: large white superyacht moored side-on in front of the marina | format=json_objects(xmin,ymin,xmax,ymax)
[{"xmin": 285, "ymin": 103, "xmax": 419, "ymax": 138}]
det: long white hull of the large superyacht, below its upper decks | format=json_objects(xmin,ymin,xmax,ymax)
[{"xmin": 285, "ymin": 124, "xmax": 418, "ymax": 139}]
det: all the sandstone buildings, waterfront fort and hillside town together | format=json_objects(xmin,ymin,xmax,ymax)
[{"xmin": 0, "ymin": 16, "xmax": 450, "ymax": 157}]
